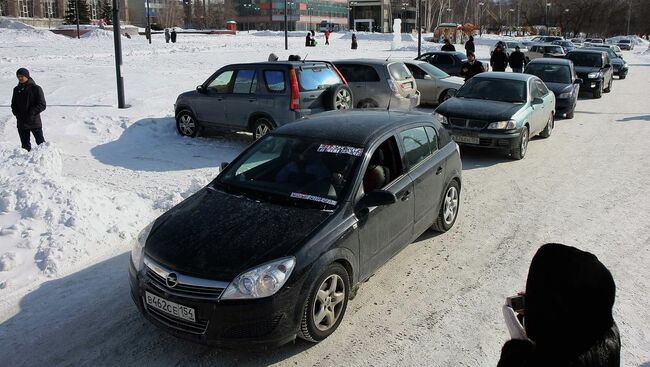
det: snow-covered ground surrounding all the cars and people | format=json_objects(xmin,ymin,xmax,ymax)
[{"xmin": 0, "ymin": 22, "xmax": 650, "ymax": 366}]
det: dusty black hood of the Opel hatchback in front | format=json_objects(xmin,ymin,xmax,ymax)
[{"xmin": 145, "ymin": 187, "xmax": 332, "ymax": 280}]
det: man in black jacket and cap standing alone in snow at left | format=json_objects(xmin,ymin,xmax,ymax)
[{"xmin": 11, "ymin": 68, "xmax": 46, "ymax": 152}]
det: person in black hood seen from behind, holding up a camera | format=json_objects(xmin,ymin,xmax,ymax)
[{"xmin": 497, "ymin": 243, "xmax": 621, "ymax": 367}]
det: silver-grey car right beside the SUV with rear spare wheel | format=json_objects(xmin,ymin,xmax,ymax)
[{"xmin": 334, "ymin": 59, "xmax": 420, "ymax": 110}]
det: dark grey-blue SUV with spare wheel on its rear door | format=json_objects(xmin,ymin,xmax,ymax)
[{"xmin": 174, "ymin": 61, "xmax": 354, "ymax": 139}]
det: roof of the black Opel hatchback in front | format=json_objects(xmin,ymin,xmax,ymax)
[{"xmin": 272, "ymin": 109, "xmax": 434, "ymax": 147}]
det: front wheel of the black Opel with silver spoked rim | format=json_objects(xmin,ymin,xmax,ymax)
[{"xmin": 298, "ymin": 263, "xmax": 350, "ymax": 343}]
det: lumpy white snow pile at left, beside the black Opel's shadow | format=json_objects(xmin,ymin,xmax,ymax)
[{"xmin": 0, "ymin": 143, "xmax": 154, "ymax": 289}]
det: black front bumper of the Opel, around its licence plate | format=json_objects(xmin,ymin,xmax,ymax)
[{"xmin": 129, "ymin": 260, "xmax": 304, "ymax": 348}]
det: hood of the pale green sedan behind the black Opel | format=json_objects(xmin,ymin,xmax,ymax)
[{"xmin": 436, "ymin": 98, "xmax": 525, "ymax": 121}]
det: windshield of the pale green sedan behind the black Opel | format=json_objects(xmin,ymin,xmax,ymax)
[{"xmin": 456, "ymin": 78, "xmax": 526, "ymax": 103}]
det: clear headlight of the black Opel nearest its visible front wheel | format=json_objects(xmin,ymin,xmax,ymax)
[{"xmin": 221, "ymin": 256, "xmax": 296, "ymax": 299}]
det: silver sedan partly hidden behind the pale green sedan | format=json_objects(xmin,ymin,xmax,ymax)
[{"xmin": 404, "ymin": 60, "xmax": 465, "ymax": 104}]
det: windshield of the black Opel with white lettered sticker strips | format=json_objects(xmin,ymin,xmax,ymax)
[{"xmin": 214, "ymin": 135, "xmax": 363, "ymax": 209}]
